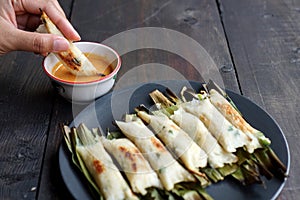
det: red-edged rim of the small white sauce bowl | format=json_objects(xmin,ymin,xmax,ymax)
[{"xmin": 42, "ymin": 41, "xmax": 122, "ymax": 85}]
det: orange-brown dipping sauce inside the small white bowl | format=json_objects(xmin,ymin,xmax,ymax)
[{"xmin": 52, "ymin": 53, "xmax": 114, "ymax": 83}]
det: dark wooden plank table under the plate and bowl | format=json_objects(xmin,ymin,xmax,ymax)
[{"xmin": 0, "ymin": 0, "xmax": 300, "ymax": 200}]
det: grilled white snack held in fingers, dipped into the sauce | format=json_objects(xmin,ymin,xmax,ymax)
[{"xmin": 37, "ymin": 10, "xmax": 104, "ymax": 76}]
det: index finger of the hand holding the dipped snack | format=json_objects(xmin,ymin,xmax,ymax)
[{"xmin": 22, "ymin": 0, "xmax": 80, "ymax": 41}]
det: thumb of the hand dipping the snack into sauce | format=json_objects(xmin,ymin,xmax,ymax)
[{"xmin": 14, "ymin": 30, "xmax": 69, "ymax": 54}]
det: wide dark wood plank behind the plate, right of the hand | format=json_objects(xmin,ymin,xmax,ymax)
[{"xmin": 71, "ymin": 0, "xmax": 238, "ymax": 91}]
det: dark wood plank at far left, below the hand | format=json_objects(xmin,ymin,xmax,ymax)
[{"xmin": 0, "ymin": 52, "xmax": 54, "ymax": 199}]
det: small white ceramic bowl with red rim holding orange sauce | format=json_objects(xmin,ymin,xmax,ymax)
[{"xmin": 43, "ymin": 42, "xmax": 121, "ymax": 104}]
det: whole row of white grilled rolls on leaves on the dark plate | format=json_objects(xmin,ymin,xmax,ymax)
[{"xmin": 59, "ymin": 80, "xmax": 287, "ymax": 200}]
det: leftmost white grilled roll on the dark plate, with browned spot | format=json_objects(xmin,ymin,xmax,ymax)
[{"xmin": 65, "ymin": 124, "xmax": 138, "ymax": 200}]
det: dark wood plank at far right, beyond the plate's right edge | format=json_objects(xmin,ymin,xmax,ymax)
[{"xmin": 220, "ymin": 0, "xmax": 300, "ymax": 199}]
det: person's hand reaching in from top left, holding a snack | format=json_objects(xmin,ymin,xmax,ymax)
[{"xmin": 0, "ymin": 0, "xmax": 80, "ymax": 55}]
